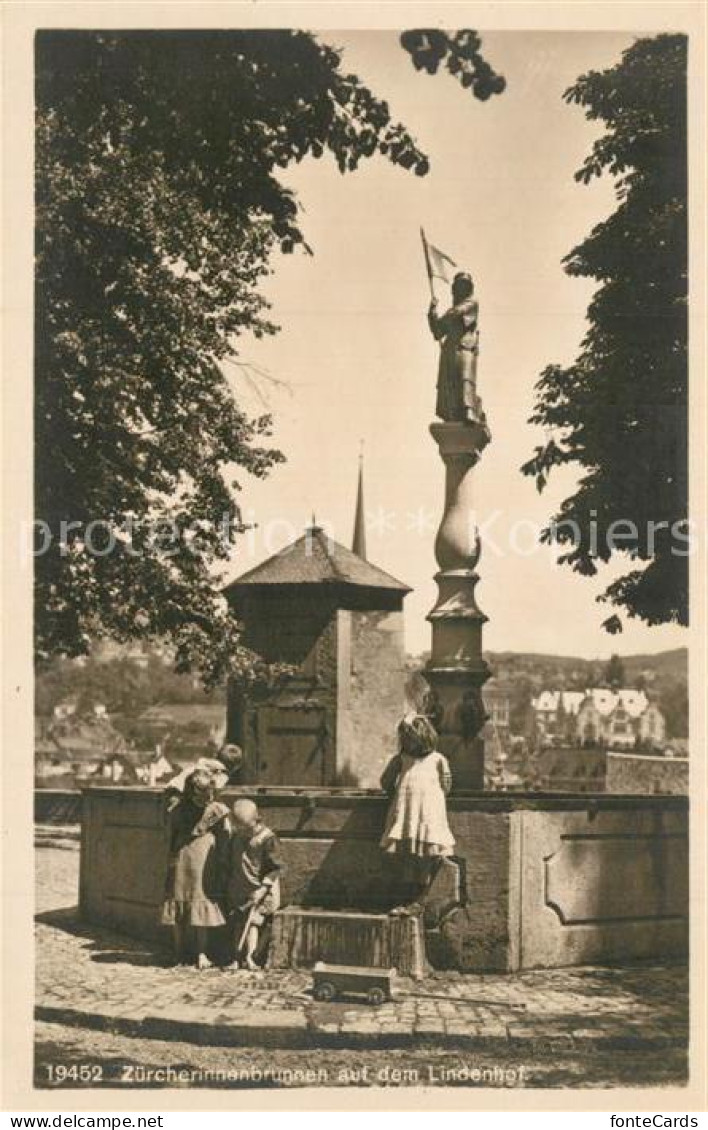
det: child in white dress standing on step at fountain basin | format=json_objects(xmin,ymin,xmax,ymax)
[{"xmin": 381, "ymin": 714, "xmax": 455, "ymax": 914}]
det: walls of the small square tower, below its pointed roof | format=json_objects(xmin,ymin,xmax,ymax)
[{"xmin": 228, "ymin": 591, "xmax": 405, "ymax": 788}]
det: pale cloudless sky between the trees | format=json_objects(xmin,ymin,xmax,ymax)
[{"xmin": 220, "ymin": 31, "xmax": 687, "ymax": 658}]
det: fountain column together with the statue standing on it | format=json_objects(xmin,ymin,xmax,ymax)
[{"xmin": 425, "ymin": 272, "xmax": 491, "ymax": 791}]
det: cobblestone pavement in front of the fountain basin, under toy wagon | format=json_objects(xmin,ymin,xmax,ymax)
[{"xmin": 36, "ymin": 829, "xmax": 688, "ymax": 1085}]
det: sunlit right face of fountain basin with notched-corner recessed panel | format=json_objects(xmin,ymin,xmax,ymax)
[{"xmin": 519, "ymin": 797, "xmax": 689, "ymax": 968}]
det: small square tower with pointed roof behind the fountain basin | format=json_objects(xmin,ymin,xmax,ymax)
[{"xmin": 226, "ymin": 515, "xmax": 410, "ymax": 788}]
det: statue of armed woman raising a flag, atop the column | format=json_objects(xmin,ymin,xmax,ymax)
[{"xmin": 421, "ymin": 231, "xmax": 486, "ymax": 424}]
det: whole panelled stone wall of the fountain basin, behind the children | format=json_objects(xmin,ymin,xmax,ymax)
[{"xmin": 80, "ymin": 788, "xmax": 688, "ymax": 972}]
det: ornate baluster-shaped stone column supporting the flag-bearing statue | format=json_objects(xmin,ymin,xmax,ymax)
[{"xmin": 425, "ymin": 421, "xmax": 490, "ymax": 791}]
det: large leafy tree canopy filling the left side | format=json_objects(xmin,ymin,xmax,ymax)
[{"xmin": 35, "ymin": 31, "xmax": 501, "ymax": 681}]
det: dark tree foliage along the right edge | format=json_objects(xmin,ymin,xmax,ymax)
[{"xmin": 523, "ymin": 35, "xmax": 688, "ymax": 632}]
